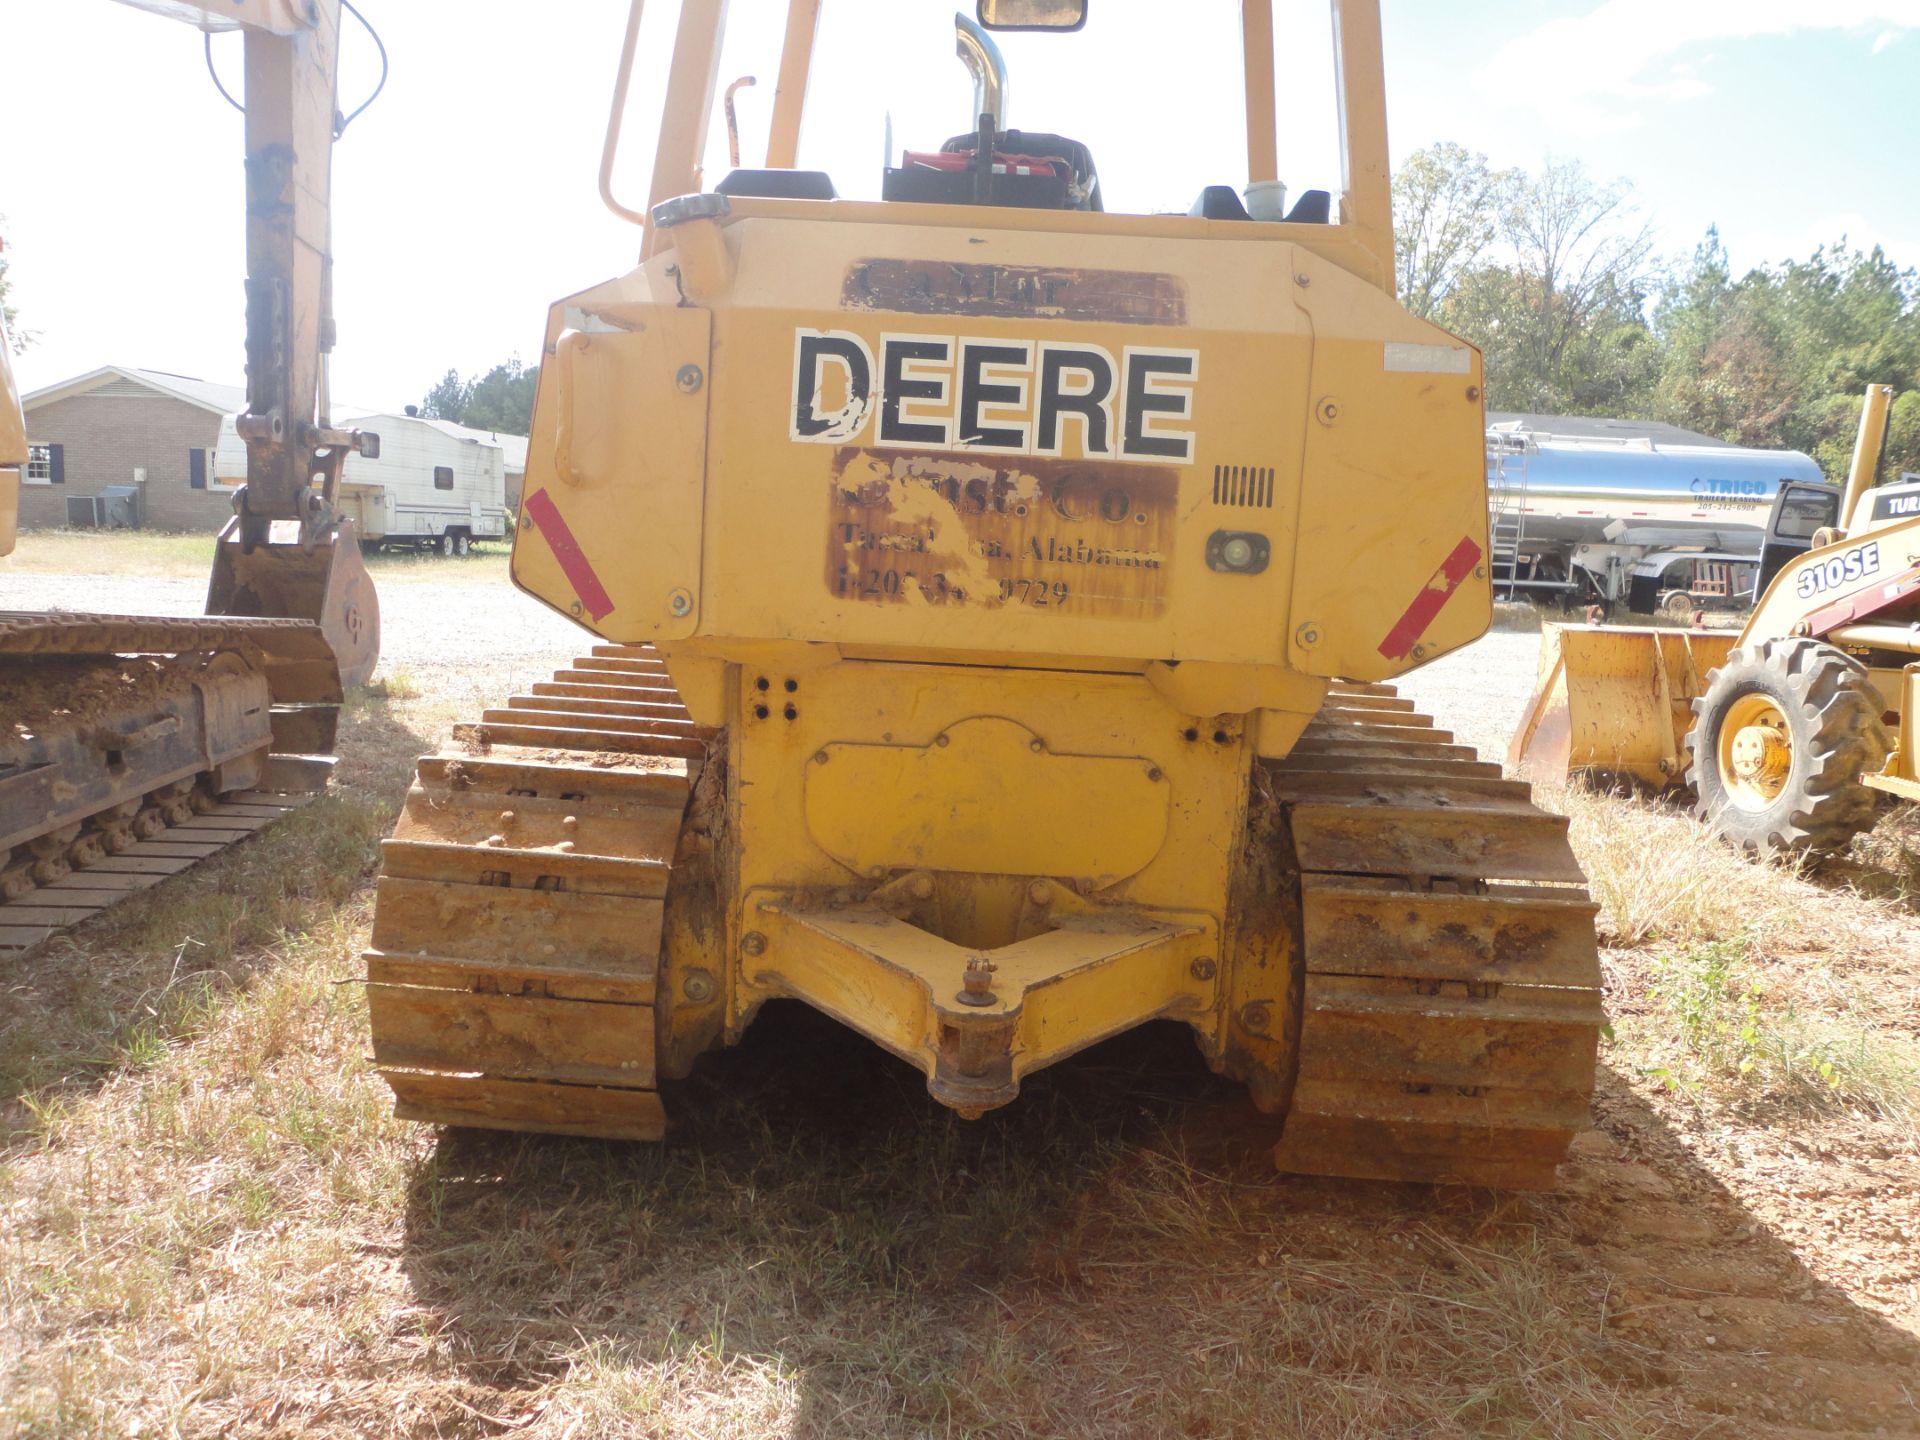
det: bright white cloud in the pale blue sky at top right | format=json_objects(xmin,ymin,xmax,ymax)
[{"xmin": 1478, "ymin": 0, "xmax": 1920, "ymax": 132}]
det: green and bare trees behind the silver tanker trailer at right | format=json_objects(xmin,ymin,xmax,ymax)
[{"xmin": 1394, "ymin": 144, "xmax": 1920, "ymax": 478}]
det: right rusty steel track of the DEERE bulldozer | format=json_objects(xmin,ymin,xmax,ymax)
[{"xmin": 1265, "ymin": 685, "xmax": 1605, "ymax": 1190}]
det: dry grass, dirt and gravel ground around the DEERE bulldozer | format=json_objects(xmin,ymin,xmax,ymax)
[{"xmin": 0, "ymin": 545, "xmax": 1920, "ymax": 1440}]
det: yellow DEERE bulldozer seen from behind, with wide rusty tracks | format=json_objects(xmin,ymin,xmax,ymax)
[{"xmin": 365, "ymin": 0, "xmax": 1603, "ymax": 1188}]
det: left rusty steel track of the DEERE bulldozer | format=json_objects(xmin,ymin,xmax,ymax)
[{"xmin": 367, "ymin": 645, "xmax": 714, "ymax": 1140}]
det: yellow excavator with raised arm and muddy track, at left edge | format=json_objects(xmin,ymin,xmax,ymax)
[{"xmin": 0, "ymin": 0, "xmax": 380, "ymax": 956}]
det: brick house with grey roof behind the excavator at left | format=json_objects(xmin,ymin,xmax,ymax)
[{"xmin": 19, "ymin": 365, "xmax": 246, "ymax": 532}]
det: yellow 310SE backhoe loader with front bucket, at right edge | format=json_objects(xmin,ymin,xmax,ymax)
[{"xmin": 1509, "ymin": 386, "xmax": 1920, "ymax": 858}]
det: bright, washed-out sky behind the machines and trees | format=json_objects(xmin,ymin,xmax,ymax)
[{"xmin": 0, "ymin": 0, "xmax": 1920, "ymax": 409}]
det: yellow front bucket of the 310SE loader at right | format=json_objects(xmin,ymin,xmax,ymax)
[{"xmin": 1507, "ymin": 626, "xmax": 1740, "ymax": 789}]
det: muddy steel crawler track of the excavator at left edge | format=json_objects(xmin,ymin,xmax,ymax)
[{"xmin": 0, "ymin": 611, "xmax": 342, "ymax": 956}]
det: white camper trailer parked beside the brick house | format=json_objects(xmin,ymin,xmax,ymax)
[{"xmin": 213, "ymin": 413, "xmax": 507, "ymax": 555}]
